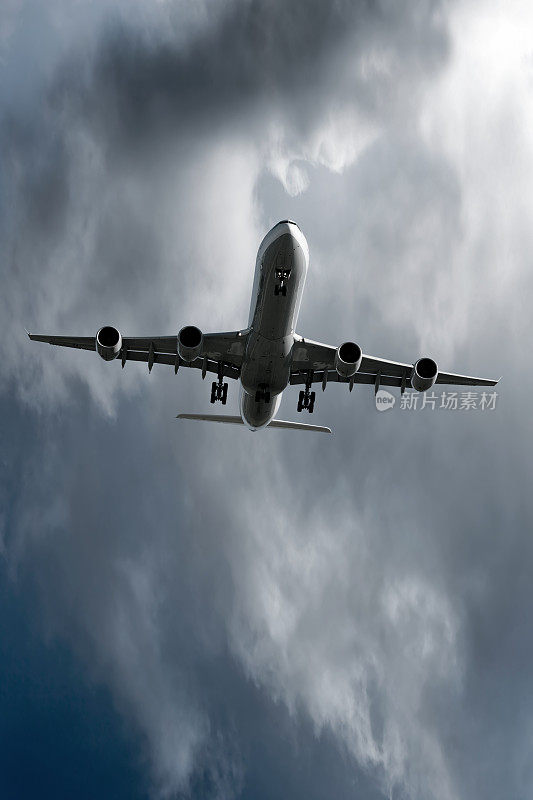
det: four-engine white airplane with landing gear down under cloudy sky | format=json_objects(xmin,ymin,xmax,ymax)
[{"xmin": 28, "ymin": 219, "xmax": 498, "ymax": 433}]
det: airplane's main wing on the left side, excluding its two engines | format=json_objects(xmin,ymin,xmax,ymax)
[{"xmin": 28, "ymin": 331, "xmax": 248, "ymax": 378}]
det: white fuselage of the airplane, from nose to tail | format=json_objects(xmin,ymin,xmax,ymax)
[{"xmin": 240, "ymin": 220, "xmax": 309, "ymax": 430}]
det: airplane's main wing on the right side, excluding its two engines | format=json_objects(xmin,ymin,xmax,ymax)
[{"xmin": 290, "ymin": 337, "xmax": 499, "ymax": 391}]
